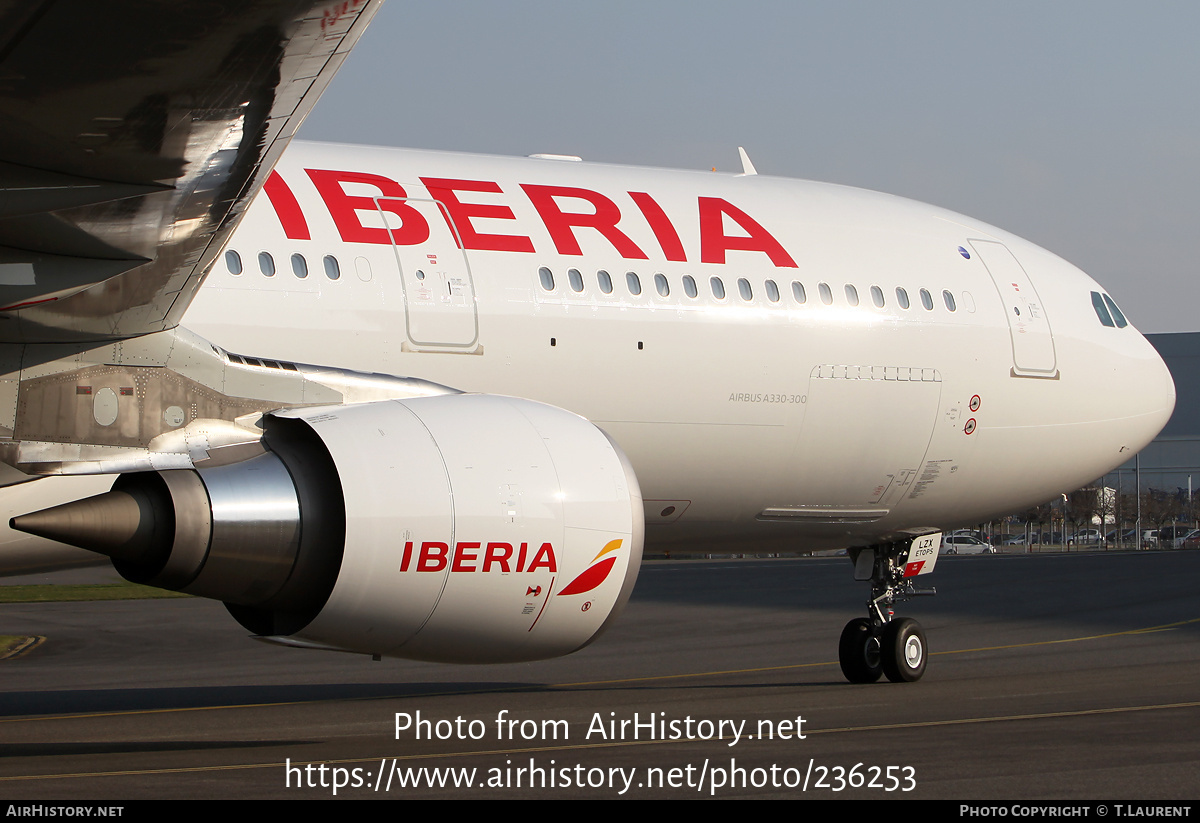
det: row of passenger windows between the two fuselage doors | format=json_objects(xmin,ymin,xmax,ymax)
[{"xmin": 538, "ymin": 266, "xmax": 958, "ymax": 312}]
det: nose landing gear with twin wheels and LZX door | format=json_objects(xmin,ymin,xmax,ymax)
[{"xmin": 838, "ymin": 534, "xmax": 942, "ymax": 683}]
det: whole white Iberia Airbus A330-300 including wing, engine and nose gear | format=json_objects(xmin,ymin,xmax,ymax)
[{"xmin": 0, "ymin": 0, "xmax": 1175, "ymax": 683}]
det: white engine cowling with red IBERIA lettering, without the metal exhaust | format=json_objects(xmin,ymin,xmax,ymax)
[{"xmin": 268, "ymin": 395, "xmax": 643, "ymax": 662}]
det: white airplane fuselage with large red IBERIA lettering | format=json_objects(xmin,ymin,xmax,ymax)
[{"xmin": 185, "ymin": 143, "xmax": 1175, "ymax": 549}]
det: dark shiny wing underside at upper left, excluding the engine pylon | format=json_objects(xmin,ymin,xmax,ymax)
[{"xmin": 0, "ymin": 0, "xmax": 382, "ymax": 343}]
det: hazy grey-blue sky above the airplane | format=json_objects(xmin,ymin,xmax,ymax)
[{"xmin": 301, "ymin": 0, "xmax": 1200, "ymax": 332}]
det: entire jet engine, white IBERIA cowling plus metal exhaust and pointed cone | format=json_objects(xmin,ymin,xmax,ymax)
[{"xmin": 14, "ymin": 395, "xmax": 643, "ymax": 662}]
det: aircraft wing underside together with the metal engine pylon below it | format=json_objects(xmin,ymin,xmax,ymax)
[{"xmin": 0, "ymin": 0, "xmax": 458, "ymax": 486}]
